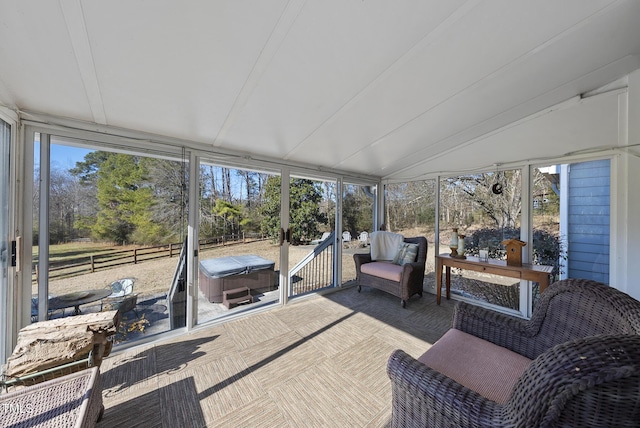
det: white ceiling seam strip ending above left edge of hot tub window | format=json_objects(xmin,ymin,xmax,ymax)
[{"xmin": 213, "ymin": 0, "xmax": 307, "ymax": 147}]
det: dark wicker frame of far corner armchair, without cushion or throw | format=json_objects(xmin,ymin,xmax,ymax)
[{"xmin": 353, "ymin": 236, "xmax": 427, "ymax": 308}]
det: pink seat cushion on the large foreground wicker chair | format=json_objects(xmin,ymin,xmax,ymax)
[{"xmin": 418, "ymin": 329, "xmax": 531, "ymax": 404}]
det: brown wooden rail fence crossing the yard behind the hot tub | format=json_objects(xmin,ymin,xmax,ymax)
[{"xmin": 32, "ymin": 233, "xmax": 267, "ymax": 283}]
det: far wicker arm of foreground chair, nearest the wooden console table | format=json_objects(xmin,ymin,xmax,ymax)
[{"xmin": 452, "ymin": 302, "xmax": 537, "ymax": 359}]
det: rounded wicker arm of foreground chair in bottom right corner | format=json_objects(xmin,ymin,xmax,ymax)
[{"xmin": 504, "ymin": 335, "xmax": 640, "ymax": 427}]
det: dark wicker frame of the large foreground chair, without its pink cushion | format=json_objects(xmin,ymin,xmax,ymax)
[{"xmin": 387, "ymin": 279, "xmax": 640, "ymax": 427}]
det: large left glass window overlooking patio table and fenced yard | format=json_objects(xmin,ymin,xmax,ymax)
[{"xmin": 32, "ymin": 135, "xmax": 188, "ymax": 342}]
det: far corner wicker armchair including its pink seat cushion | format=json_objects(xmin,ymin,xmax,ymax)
[{"xmin": 353, "ymin": 233, "xmax": 427, "ymax": 308}]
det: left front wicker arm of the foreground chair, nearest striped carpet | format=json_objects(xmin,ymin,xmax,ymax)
[{"xmin": 387, "ymin": 350, "xmax": 503, "ymax": 428}]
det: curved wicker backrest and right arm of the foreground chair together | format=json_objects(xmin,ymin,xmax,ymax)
[{"xmin": 503, "ymin": 279, "xmax": 640, "ymax": 427}]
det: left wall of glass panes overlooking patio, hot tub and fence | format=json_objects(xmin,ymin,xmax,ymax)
[{"xmin": 27, "ymin": 127, "xmax": 364, "ymax": 342}]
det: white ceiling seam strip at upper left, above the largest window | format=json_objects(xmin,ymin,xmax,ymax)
[{"xmin": 59, "ymin": 0, "xmax": 107, "ymax": 125}]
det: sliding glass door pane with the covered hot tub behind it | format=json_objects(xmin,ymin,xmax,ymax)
[{"xmin": 195, "ymin": 159, "xmax": 287, "ymax": 324}]
